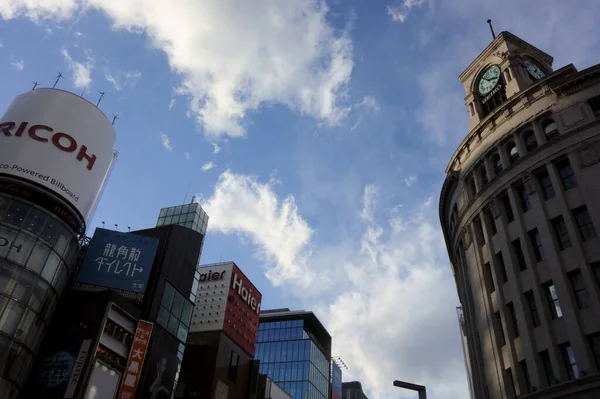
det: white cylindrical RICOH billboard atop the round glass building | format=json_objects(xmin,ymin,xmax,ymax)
[{"xmin": 0, "ymin": 89, "xmax": 116, "ymax": 223}]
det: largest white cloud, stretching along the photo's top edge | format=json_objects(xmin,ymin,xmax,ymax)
[{"xmin": 0, "ymin": 0, "xmax": 354, "ymax": 137}]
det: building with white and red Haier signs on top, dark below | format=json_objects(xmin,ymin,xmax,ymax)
[{"xmin": 175, "ymin": 262, "xmax": 262, "ymax": 399}]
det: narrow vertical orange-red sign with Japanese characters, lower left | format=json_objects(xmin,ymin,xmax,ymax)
[{"xmin": 117, "ymin": 320, "xmax": 154, "ymax": 399}]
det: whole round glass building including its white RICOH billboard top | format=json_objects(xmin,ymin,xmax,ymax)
[{"xmin": 0, "ymin": 89, "xmax": 116, "ymax": 399}]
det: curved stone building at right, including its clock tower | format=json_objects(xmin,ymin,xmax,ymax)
[{"xmin": 440, "ymin": 32, "xmax": 600, "ymax": 399}]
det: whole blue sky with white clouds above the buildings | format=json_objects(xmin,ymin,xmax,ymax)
[{"xmin": 0, "ymin": 0, "xmax": 600, "ymax": 399}]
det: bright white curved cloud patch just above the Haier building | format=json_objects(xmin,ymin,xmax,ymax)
[{"xmin": 202, "ymin": 170, "xmax": 314, "ymax": 287}]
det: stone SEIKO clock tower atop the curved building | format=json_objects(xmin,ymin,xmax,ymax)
[{"xmin": 459, "ymin": 32, "xmax": 553, "ymax": 130}]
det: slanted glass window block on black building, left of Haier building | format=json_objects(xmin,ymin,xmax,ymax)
[{"xmin": 156, "ymin": 282, "xmax": 194, "ymax": 342}]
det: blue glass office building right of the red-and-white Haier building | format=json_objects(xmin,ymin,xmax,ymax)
[{"xmin": 254, "ymin": 309, "xmax": 331, "ymax": 399}]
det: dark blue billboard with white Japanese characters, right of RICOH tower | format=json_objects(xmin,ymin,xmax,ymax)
[{"xmin": 77, "ymin": 228, "xmax": 158, "ymax": 293}]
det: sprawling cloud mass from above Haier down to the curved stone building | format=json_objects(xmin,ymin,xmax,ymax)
[{"xmin": 202, "ymin": 171, "xmax": 468, "ymax": 399}]
